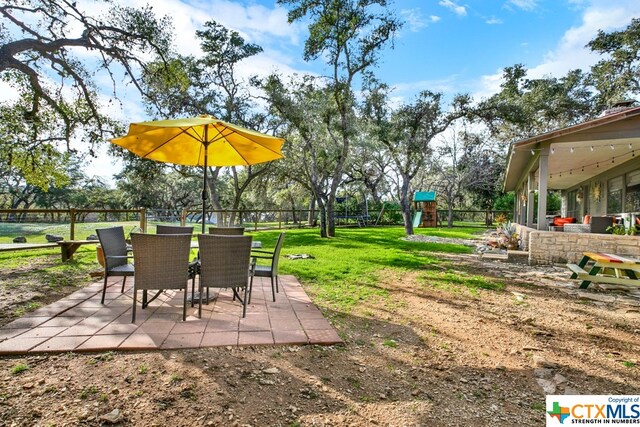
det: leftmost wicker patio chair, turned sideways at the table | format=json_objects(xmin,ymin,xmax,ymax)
[{"xmin": 96, "ymin": 227, "xmax": 134, "ymax": 304}]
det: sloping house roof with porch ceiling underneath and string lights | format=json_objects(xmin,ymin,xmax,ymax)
[{"xmin": 503, "ymin": 107, "xmax": 640, "ymax": 191}]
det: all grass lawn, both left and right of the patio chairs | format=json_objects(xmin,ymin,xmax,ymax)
[{"xmin": 0, "ymin": 227, "xmax": 501, "ymax": 318}]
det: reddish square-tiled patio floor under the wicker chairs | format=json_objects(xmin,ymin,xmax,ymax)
[{"xmin": 0, "ymin": 276, "xmax": 342, "ymax": 355}]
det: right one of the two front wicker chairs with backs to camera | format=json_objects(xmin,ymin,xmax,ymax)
[{"xmin": 198, "ymin": 234, "xmax": 253, "ymax": 317}]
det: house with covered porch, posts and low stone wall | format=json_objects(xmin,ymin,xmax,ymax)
[{"xmin": 503, "ymin": 105, "xmax": 640, "ymax": 263}]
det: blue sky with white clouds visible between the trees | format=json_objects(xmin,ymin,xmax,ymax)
[{"xmin": 5, "ymin": 0, "xmax": 640, "ymax": 182}]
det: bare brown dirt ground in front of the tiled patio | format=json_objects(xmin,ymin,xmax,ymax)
[{"xmin": 0, "ymin": 242, "xmax": 640, "ymax": 426}]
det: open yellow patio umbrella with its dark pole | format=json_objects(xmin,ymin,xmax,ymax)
[{"xmin": 111, "ymin": 115, "xmax": 284, "ymax": 233}]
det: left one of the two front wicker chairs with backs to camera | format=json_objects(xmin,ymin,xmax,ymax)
[{"xmin": 131, "ymin": 233, "xmax": 191, "ymax": 323}]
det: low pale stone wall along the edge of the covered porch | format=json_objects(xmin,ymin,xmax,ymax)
[{"xmin": 525, "ymin": 230, "xmax": 640, "ymax": 265}]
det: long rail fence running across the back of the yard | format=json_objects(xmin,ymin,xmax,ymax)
[{"xmin": 0, "ymin": 209, "xmax": 504, "ymax": 243}]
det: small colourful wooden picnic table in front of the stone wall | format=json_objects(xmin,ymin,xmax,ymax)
[{"xmin": 567, "ymin": 252, "xmax": 640, "ymax": 289}]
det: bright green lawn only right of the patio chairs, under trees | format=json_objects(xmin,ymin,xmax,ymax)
[{"xmin": 252, "ymin": 227, "xmax": 492, "ymax": 311}]
